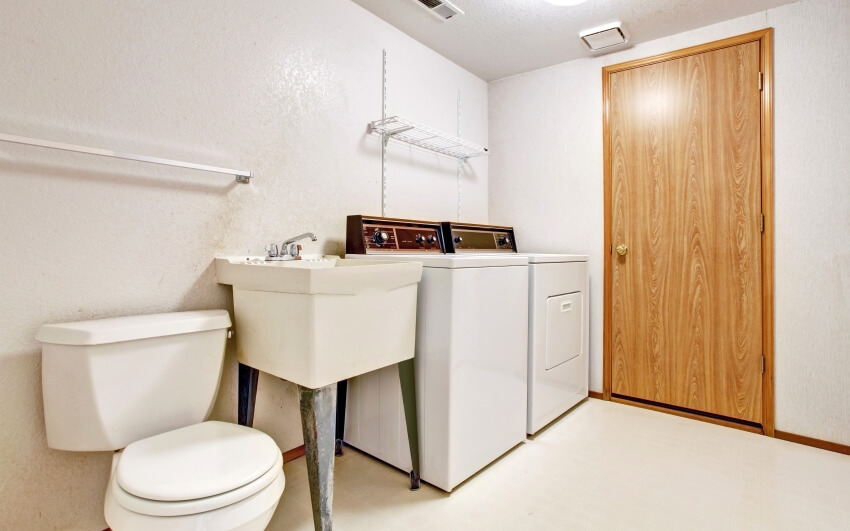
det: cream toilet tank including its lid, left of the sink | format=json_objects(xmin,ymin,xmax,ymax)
[{"xmin": 36, "ymin": 310, "xmax": 230, "ymax": 451}]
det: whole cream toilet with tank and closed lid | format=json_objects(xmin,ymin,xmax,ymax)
[{"xmin": 36, "ymin": 310, "xmax": 285, "ymax": 531}]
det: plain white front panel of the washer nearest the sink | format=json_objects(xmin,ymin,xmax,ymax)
[{"xmin": 448, "ymin": 267, "xmax": 528, "ymax": 487}]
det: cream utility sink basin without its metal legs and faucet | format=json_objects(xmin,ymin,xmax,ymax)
[{"xmin": 215, "ymin": 255, "xmax": 422, "ymax": 389}]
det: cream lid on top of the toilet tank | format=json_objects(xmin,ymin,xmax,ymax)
[{"xmin": 35, "ymin": 310, "xmax": 230, "ymax": 345}]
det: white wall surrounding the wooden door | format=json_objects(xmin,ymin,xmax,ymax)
[{"xmin": 490, "ymin": 0, "xmax": 850, "ymax": 444}]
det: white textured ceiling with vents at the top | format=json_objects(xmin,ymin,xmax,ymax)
[{"xmin": 346, "ymin": 0, "xmax": 796, "ymax": 81}]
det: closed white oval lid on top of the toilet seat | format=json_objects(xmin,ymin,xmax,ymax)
[{"xmin": 116, "ymin": 421, "xmax": 280, "ymax": 501}]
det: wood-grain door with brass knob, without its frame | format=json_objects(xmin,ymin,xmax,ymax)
[{"xmin": 606, "ymin": 41, "xmax": 763, "ymax": 424}]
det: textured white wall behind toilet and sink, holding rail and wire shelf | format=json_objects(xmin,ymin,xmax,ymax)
[{"xmin": 0, "ymin": 0, "xmax": 487, "ymax": 530}]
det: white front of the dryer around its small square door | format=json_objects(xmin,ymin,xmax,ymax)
[{"xmin": 526, "ymin": 262, "xmax": 590, "ymax": 433}]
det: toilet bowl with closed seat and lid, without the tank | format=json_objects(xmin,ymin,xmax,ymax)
[{"xmin": 104, "ymin": 421, "xmax": 285, "ymax": 531}]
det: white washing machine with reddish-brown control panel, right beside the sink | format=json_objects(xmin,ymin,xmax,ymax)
[{"xmin": 343, "ymin": 216, "xmax": 528, "ymax": 492}]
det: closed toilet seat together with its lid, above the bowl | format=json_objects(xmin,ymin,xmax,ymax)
[{"xmin": 109, "ymin": 421, "xmax": 283, "ymax": 516}]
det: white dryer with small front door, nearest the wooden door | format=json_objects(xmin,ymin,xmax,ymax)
[{"xmin": 442, "ymin": 222, "xmax": 590, "ymax": 434}]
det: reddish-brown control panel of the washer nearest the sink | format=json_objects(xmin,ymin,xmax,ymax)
[{"xmin": 345, "ymin": 216, "xmax": 445, "ymax": 254}]
